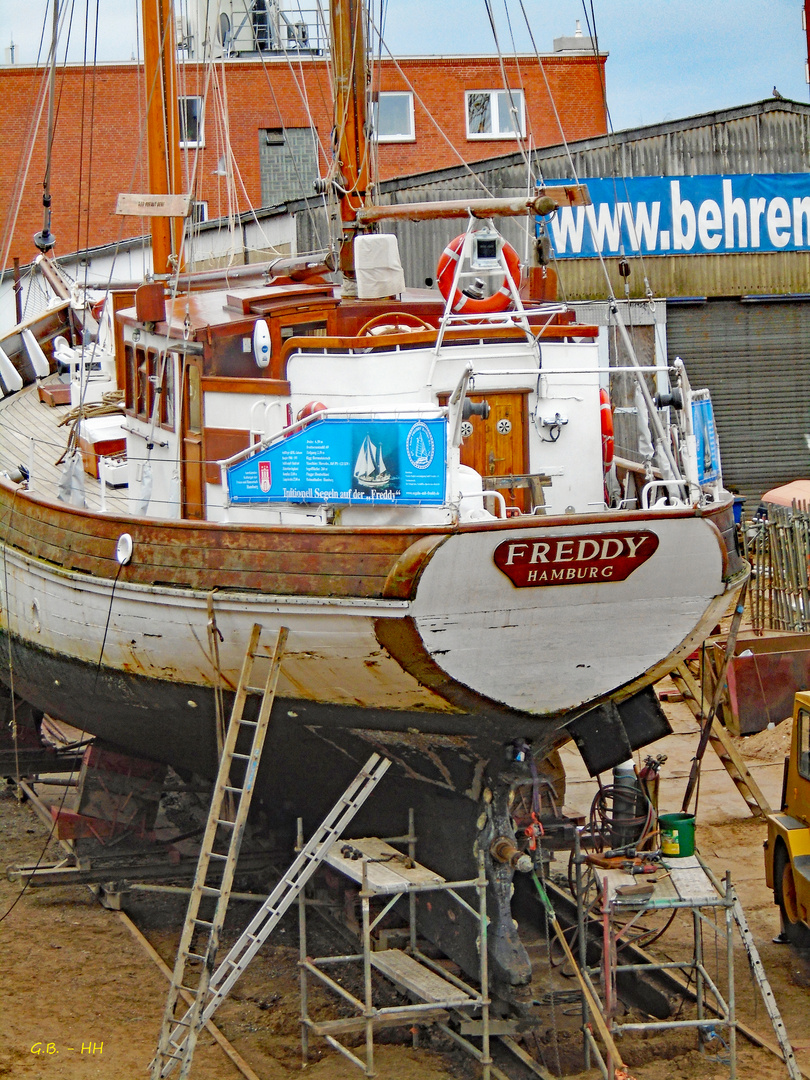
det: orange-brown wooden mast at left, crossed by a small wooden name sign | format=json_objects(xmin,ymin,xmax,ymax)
[{"xmin": 141, "ymin": 0, "xmax": 184, "ymax": 274}]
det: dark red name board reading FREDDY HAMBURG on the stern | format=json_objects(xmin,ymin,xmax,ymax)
[{"xmin": 492, "ymin": 532, "xmax": 658, "ymax": 589}]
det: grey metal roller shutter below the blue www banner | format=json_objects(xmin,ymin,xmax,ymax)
[{"xmin": 666, "ymin": 299, "xmax": 810, "ymax": 513}]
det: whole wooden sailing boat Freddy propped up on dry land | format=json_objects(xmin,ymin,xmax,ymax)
[{"xmin": 0, "ymin": 0, "xmax": 747, "ymax": 987}]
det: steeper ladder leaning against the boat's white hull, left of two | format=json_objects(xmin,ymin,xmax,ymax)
[{"xmin": 151, "ymin": 623, "xmax": 287, "ymax": 1080}]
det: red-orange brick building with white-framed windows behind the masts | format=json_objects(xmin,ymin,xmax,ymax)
[{"xmin": 0, "ymin": 49, "xmax": 606, "ymax": 262}]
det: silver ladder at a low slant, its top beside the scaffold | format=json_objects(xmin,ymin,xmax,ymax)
[{"xmin": 152, "ymin": 754, "xmax": 391, "ymax": 1080}]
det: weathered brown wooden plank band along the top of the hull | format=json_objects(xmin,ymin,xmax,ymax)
[{"xmin": 0, "ymin": 468, "xmax": 729, "ymax": 598}]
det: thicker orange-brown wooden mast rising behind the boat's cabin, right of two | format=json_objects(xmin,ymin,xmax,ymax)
[{"xmin": 329, "ymin": 0, "xmax": 370, "ymax": 293}]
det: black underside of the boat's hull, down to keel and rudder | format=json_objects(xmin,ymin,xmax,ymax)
[{"xmin": 0, "ymin": 635, "xmax": 673, "ymax": 994}]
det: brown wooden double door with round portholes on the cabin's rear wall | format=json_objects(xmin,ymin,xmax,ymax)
[{"xmin": 461, "ymin": 390, "xmax": 531, "ymax": 513}]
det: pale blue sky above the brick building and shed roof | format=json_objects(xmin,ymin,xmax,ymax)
[{"xmin": 0, "ymin": 0, "xmax": 810, "ymax": 131}]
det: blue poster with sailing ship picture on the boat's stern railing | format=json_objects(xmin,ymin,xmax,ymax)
[{"xmin": 228, "ymin": 417, "xmax": 447, "ymax": 505}]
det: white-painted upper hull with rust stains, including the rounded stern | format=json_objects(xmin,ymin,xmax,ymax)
[{"xmin": 3, "ymin": 515, "xmax": 728, "ymax": 716}]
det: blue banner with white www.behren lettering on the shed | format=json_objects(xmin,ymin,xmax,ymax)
[{"xmin": 549, "ymin": 173, "xmax": 810, "ymax": 258}]
